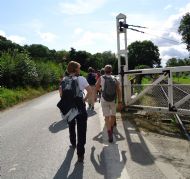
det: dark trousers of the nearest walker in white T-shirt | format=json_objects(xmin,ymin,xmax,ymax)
[{"xmin": 69, "ymin": 109, "xmax": 87, "ymax": 156}]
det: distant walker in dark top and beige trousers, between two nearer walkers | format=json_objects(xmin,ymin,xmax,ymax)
[{"xmin": 86, "ymin": 67, "xmax": 96, "ymax": 110}]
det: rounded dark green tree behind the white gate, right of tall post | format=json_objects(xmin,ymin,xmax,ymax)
[{"xmin": 128, "ymin": 40, "xmax": 161, "ymax": 70}]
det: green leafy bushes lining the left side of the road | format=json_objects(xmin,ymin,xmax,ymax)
[{"xmin": 0, "ymin": 50, "xmax": 63, "ymax": 88}]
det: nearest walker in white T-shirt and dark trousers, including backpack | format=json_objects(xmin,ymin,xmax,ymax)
[{"xmin": 59, "ymin": 61, "xmax": 91, "ymax": 162}]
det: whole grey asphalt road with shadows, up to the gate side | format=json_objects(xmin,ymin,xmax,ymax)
[{"xmin": 0, "ymin": 91, "xmax": 189, "ymax": 179}]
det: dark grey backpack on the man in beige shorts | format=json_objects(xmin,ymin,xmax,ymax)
[{"xmin": 102, "ymin": 75, "xmax": 116, "ymax": 102}]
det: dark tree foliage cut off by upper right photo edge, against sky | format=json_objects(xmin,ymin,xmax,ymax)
[{"xmin": 178, "ymin": 12, "xmax": 190, "ymax": 51}]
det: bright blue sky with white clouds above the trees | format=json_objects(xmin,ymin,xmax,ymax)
[{"xmin": 0, "ymin": 0, "xmax": 190, "ymax": 66}]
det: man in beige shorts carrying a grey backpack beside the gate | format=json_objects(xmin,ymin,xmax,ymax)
[{"xmin": 96, "ymin": 65, "xmax": 122, "ymax": 143}]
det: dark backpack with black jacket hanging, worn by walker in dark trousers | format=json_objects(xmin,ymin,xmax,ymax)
[{"xmin": 57, "ymin": 76, "xmax": 83, "ymax": 115}]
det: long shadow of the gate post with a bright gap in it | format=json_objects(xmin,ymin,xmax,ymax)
[{"xmin": 122, "ymin": 112, "xmax": 155, "ymax": 165}]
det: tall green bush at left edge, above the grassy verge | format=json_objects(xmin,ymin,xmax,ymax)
[{"xmin": 0, "ymin": 50, "xmax": 38, "ymax": 88}]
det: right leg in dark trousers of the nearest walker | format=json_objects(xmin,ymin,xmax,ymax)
[{"xmin": 77, "ymin": 112, "xmax": 87, "ymax": 162}]
